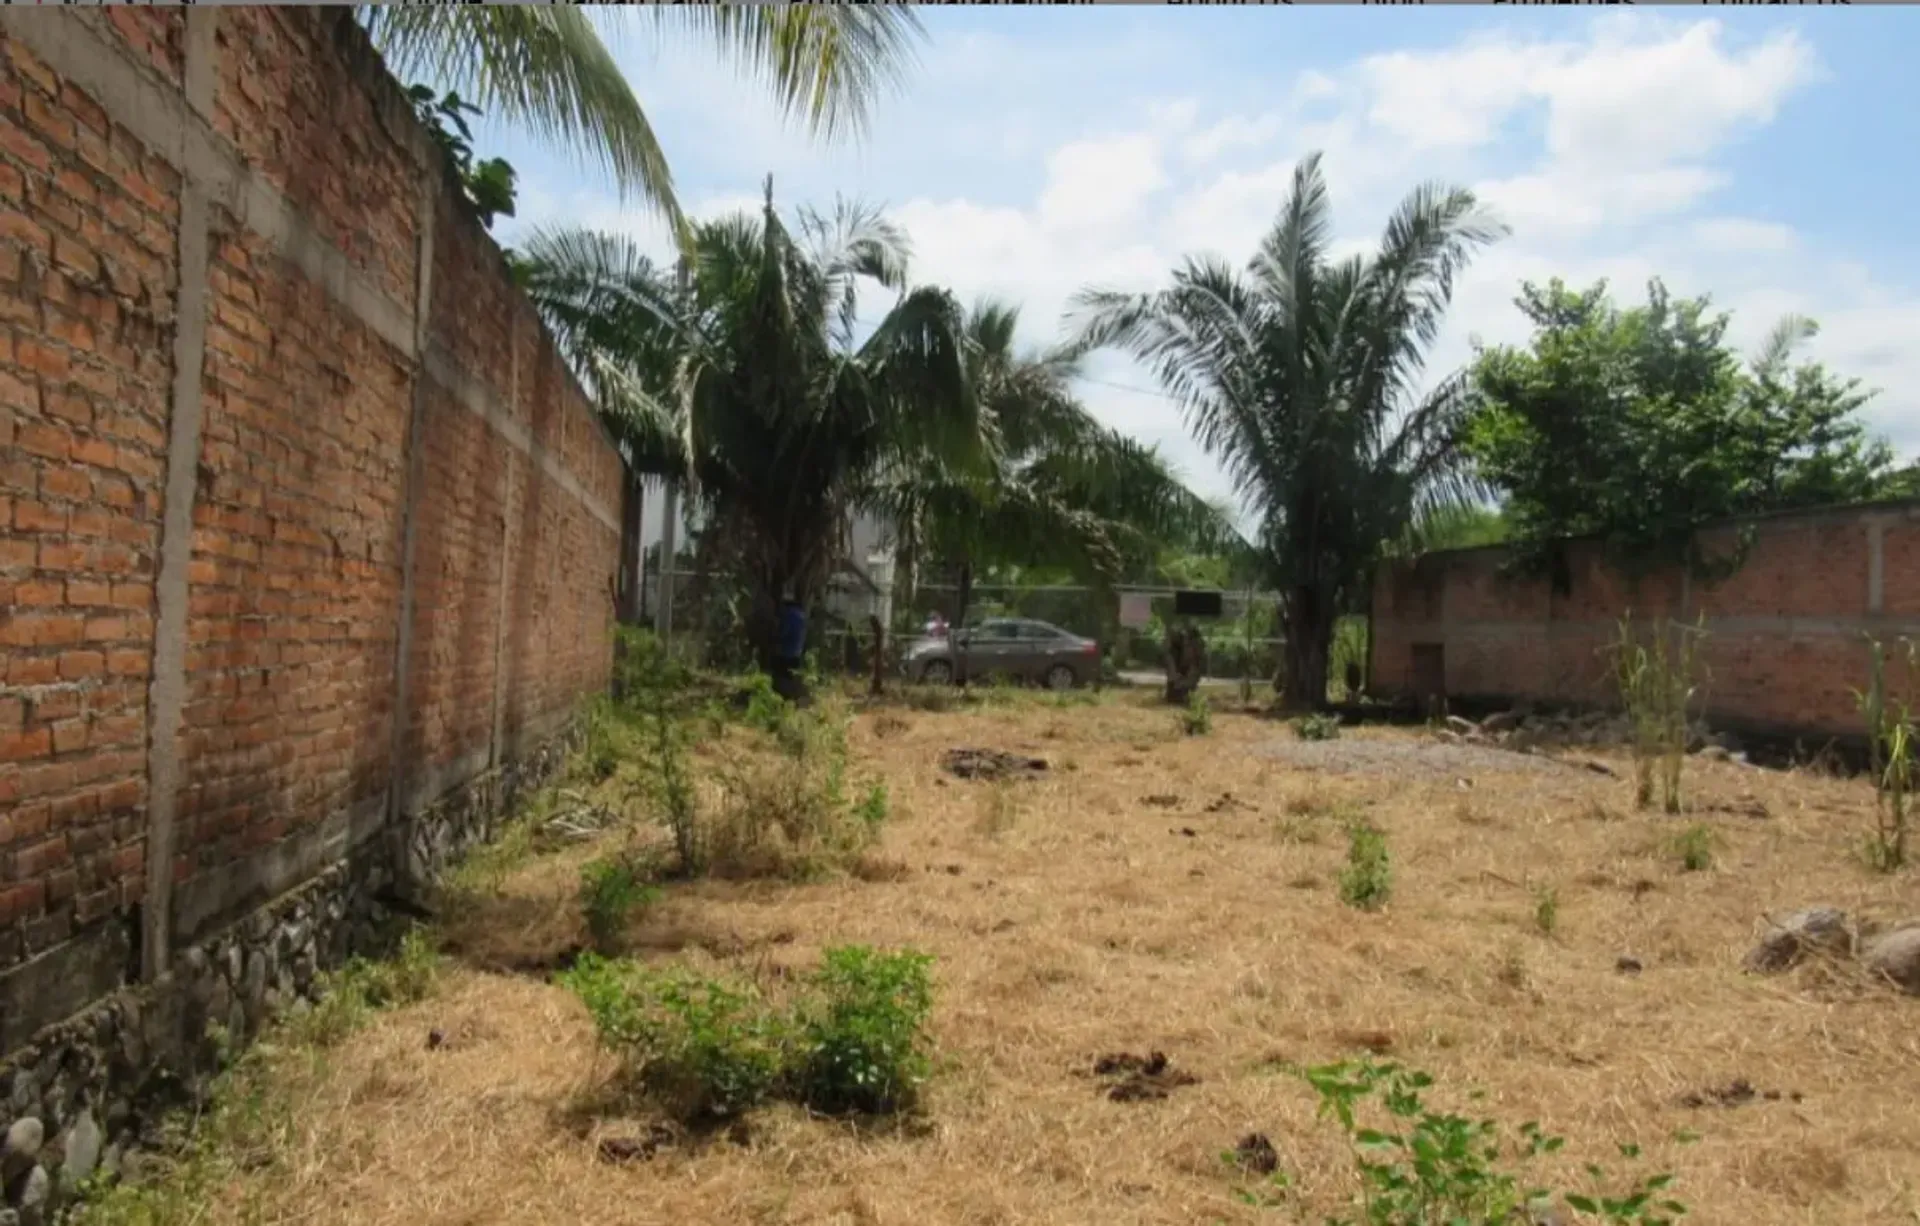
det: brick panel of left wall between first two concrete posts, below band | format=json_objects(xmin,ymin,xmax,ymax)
[{"xmin": 175, "ymin": 217, "xmax": 413, "ymax": 884}]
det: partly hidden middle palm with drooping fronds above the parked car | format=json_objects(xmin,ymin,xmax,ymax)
[{"xmin": 870, "ymin": 301, "xmax": 1227, "ymax": 679}]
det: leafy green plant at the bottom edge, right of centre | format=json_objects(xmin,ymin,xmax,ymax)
[{"xmin": 1302, "ymin": 1061, "xmax": 1688, "ymax": 1226}]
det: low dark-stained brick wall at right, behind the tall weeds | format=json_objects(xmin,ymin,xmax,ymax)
[{"xmin": 1373, "ymin": 503, "xmax": 1920, "ymax": 737}]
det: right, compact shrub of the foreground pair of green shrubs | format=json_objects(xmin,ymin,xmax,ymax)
[{"xmin": 795, "ymin": 946, "xmax": 933, "ymax": 1115}]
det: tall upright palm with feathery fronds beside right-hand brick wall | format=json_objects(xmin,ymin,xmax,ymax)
[{"xmin": 1075, "ymin": 153, "xmax": 1505, "ymax": 708}]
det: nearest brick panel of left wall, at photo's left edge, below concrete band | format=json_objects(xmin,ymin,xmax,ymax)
[{"xmin": 0, "ymin": 17, "xmax": 179, "ymax": 967}]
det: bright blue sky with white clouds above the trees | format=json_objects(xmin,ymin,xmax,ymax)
[{"xmin": 478, "ymin": 6, "xmax": 1920, "ymax": 514}]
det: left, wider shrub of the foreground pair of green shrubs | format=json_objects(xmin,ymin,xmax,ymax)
[{"xmin": 561, "ymin": 954, "xmax": 787, "ymax": 1120}]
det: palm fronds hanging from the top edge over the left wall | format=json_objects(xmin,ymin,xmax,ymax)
[{"xmin": 359, "ymin": 4, "xmax": 922, "ymax": 234}]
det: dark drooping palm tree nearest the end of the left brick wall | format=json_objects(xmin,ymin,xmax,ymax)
[{"xmin": 526, "ymin": 180, "xmax": 985, "ymax": 664}]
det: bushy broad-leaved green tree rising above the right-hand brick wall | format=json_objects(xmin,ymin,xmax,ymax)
[{"xmin": 1469, "ymin": 280, "xmax": 1893, "ymax": 576}]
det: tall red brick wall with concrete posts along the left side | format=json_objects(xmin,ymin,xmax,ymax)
[{"xmin": 0, "ymin": 8, "xmax": 620, "ymax": 1032}]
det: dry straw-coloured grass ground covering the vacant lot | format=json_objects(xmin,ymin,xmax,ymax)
[{"xmin": 112, "ymin": 696, "xmax": 1920, "ymax": 1226}]
